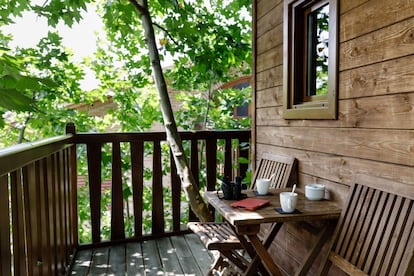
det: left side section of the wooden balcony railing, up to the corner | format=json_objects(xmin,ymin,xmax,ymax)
[{"xmin": 0, "ymin": 135, "xmax": 77, "ymax": 276}]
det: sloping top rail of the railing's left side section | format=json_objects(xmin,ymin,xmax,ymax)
[{"xmin": 0, "ymin": 134, "xmax": 73, "ymax": 175}]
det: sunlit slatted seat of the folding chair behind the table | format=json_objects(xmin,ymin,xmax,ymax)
[{"xmin": 187, "ymin": 222, "xmax": 243, "ymax": 250}]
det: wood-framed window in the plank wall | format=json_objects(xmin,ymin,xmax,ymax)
[{"xmin": 283, "ymin": 0, "xmax": 338, "ymax": 119}]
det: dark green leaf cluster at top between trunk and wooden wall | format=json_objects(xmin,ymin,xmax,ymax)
[{"xmin": 160, "ymin": 0, "xmax": 251, "ymax": 90}]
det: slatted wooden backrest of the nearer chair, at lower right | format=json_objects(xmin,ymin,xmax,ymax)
[{"xmin": 322, "ymin": 175, "xmax": 414, "ymax": 275}]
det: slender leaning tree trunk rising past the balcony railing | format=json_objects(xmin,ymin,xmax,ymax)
[{"xmin": 130, "ymin": 0, "xmax": 212, "ymax": 221}]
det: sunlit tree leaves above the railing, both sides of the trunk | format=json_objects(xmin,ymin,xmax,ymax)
[{"xmin": 0, "ymin": 0, "xmax": 251, "ymax": 147}]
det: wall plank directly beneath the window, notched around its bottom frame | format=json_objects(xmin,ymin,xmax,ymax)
[{"xmin": 256, "ymin": 92, "xmax": 414, "ymax": 130}]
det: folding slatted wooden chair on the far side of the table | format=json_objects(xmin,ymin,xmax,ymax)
[{"xmin": 188, "ymin": 154, "xmax": 297, "ymax": 275}]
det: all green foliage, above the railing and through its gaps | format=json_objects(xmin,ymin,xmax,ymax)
[{"xmin": 0, "ymin": 0, "xmax": 251, "ymax": 242}]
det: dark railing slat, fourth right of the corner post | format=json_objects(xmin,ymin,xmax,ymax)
[{"xmin": 152, "ymin": 140, "xmax": 164, "ymax": 234}]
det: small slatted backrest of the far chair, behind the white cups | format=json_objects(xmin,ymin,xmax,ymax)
[{"xmin": 251, "ymin": 153, "xmax": 297, "ymax": 189}]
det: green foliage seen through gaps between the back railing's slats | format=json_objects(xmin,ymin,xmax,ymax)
[{"xmin": 78, "ymin": 135, "xmax": 248, "ymax": 244}]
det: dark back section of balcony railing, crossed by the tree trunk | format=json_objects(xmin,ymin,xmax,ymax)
[{"xmin": 68, "ymin": 124, "xmax": 250, "ymax": 244}]
